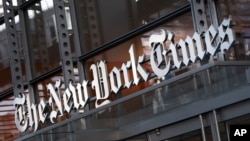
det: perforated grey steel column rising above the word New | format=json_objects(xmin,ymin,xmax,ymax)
[{"xmin": 54, "ymin": 0, "xmax": 74, "ymax": 86}]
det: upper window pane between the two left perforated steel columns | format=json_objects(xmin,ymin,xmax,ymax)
[{"xmin": 27, "ymin": 0, "xmax": 60, "ymax": 76}]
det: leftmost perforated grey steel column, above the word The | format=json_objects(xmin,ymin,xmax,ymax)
[{"xmin": 3, "ymin": 0, "xmax": 24, "ymax": 96}]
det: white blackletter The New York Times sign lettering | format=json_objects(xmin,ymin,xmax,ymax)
[{"xmin": 14, "ymin": 19, "xmax": 235, "ymax": 132}]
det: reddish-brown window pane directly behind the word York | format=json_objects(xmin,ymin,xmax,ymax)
[{"xmin": 84, "ymin": 12, "xmax": 194, "ymax": 109}]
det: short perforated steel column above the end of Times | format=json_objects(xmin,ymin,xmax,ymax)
[{"xmin": 190, "ymin": 0, "xmax": 208, "ymax": 34}]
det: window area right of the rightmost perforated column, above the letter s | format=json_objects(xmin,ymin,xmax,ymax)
[{"xmin": 218, "ymin": 0, "xmax": 250, "ymax": 60}]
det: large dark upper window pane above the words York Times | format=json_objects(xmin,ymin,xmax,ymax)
[{"xmin": 75, "ymin": 0, "xmax": 188, "ymax": 52}]
